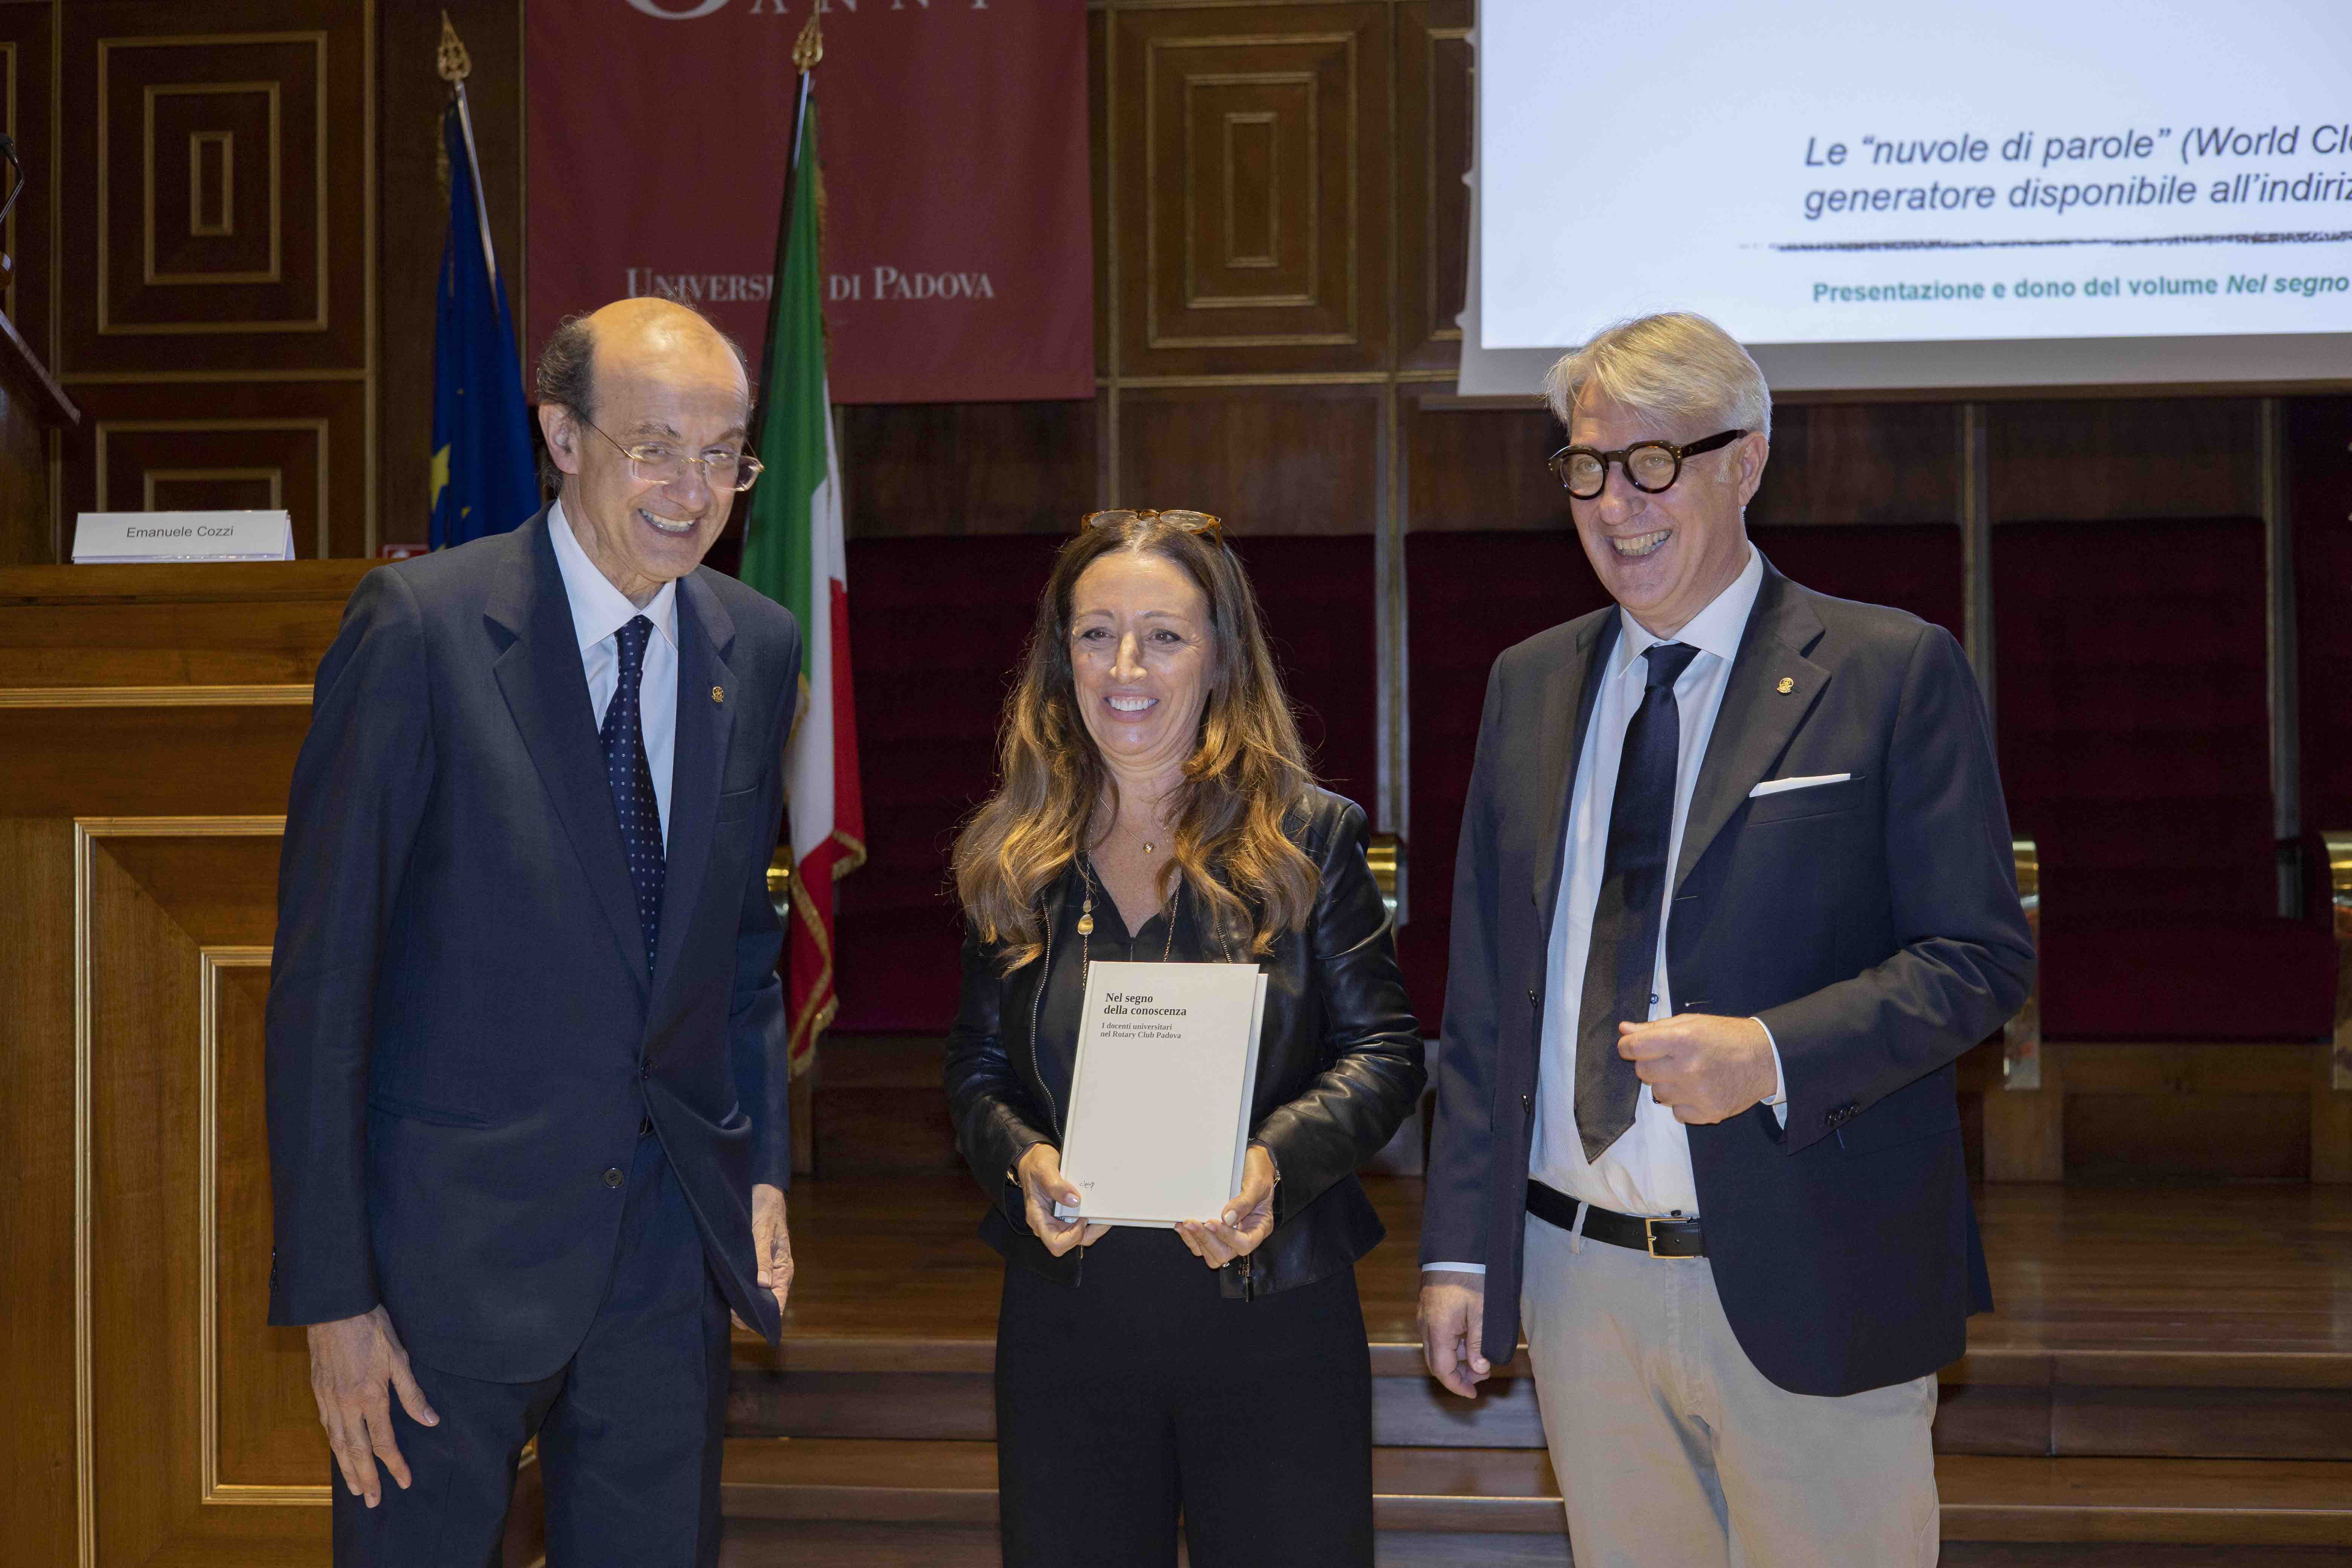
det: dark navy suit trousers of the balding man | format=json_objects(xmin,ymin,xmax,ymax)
[{"xmin": 334, "ymin": 1135, "xmax": 729, "ymax": 1568}]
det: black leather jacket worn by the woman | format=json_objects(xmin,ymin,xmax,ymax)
[{"xmin": 948, "ymin": 790, "xmax": 1428, "ymax": 1300}]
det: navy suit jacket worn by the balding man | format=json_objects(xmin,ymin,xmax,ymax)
[{"xmin": 268, "ymin": 513, "xmax": 800, "ymax": 1380}]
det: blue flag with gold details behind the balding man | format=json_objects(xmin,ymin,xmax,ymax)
[{"xmin": 433, "ymin": 87, "xmax": 539, "ymax": 550}]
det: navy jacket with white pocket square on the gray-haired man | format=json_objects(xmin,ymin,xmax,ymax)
[{"xmin": 1421, "ymin": 562, "xmax": 2032, "ymax": 1394}]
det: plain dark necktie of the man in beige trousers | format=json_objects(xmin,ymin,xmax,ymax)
[{"xmin": 1576, "ymin": 642, "xmax": 1698, "ymax": 1159}]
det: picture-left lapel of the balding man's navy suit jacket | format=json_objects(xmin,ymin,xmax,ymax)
[{"xmin": 482, "ymin": 513, "xmax": 647, "ymax": 985}]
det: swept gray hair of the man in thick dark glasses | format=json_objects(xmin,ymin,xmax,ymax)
[{"xmin": 1543, "ymin": 310, "xmax": 1771, "ymax": 439}]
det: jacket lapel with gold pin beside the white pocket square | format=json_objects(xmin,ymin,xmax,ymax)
[{"xmin": 1675, "ymin": 562, "xmax": 1830, "ymax": 889}]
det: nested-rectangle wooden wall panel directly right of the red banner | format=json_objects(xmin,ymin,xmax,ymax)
[{"xmin": 1106, "ymin": 5, "xmax": 1390, "ymax": 376}]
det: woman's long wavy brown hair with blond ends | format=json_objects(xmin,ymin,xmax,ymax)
[{"xmin": 955, "ymin": 515, "xmax": 1320, "ymax": 973}]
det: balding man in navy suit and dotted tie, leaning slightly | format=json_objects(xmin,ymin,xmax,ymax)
[{"xmin": 268, "ymin": 299, "xmax": 800, "ymax": 1568}]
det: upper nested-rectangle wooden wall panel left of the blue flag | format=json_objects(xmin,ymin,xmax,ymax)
[{"xmin": 59, "ymin": 0, "xmax": 374, "ymax": 374}]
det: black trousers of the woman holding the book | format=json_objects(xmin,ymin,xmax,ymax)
[{"xmin": 997, "ymin": 1227, "xmax": 1371, "ymax": 1568}]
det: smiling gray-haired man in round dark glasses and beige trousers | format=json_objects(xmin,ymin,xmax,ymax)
[{"xmin": 1421, "ymin": 313, "xmax": 2032, "ymax": 1568}]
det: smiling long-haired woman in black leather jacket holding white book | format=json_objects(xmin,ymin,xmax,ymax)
[{"xmin": 945, "ymin": 513, "xmax": 1425, "ymax": 1568}]
